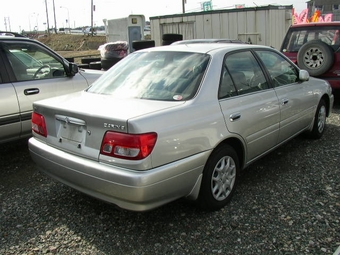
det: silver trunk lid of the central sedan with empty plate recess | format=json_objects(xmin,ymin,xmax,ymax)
[{"xmin": 34, "ymin": 92, "xmax": 184, "ymax": 160}]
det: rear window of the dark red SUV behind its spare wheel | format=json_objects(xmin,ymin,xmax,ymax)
[{"xmin": 281, "ymin": 26, "xmax": 340, "ymax": 52}]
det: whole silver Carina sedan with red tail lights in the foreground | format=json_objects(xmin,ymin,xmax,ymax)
[{"xmin": 29, "ymin": 43, "xmax": 334, "ymax": 211}]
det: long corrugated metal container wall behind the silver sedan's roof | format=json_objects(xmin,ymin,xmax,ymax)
[{"xmin": 150, "ymin": 6, "xmax": 292, "ymax": 49}]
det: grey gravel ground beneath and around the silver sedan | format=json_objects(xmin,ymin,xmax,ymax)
[{"xmin": 0, "ymin": 103, "xmax": 340, "ymax": 255}]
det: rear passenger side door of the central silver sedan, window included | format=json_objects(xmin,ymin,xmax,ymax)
[{"xmin": 219, "ymin": 50, "xmax": 280, "ymax": 162}]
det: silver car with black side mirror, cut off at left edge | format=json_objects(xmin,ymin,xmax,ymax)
[{"xmin": 0, "ymin": 32, "xmax": 103, "ymax": 143}]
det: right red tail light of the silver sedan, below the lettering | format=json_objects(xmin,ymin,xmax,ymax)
[{"xmin": 100, "ymin": 131, "xmax": 157, "ymax": 160}]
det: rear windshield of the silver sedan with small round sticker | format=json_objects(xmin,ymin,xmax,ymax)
[{"xmin": 87, "ymin": 51, "xmax": 210, "ymax": 101}]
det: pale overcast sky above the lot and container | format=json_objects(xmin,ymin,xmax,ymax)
[{"xmin": 0, "ymin": 0, "xmax": 307, "ymax": 32}]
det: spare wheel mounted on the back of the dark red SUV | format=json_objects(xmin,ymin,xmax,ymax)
[{"xmin": 297, "ymin": 40, "xmax": 334, "ymax": 76}]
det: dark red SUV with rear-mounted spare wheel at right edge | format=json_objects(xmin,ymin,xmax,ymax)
[{"xmin": 281, "ymin": 22, "xmax": 340, "ymax": 92}]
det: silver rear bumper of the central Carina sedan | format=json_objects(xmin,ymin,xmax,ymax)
[{"xmin": 29, "ymin": 137, "xmax": 209, "ymax": 211}]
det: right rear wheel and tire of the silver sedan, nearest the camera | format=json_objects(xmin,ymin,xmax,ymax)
[{"xmin": 198, "ymin": 145, "xmax": 239, "ymax": 211}]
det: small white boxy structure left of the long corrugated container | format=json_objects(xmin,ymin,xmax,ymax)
[{"xmin": 103, "ymin": 15, "xmax": 145, "ymax": 52}]
